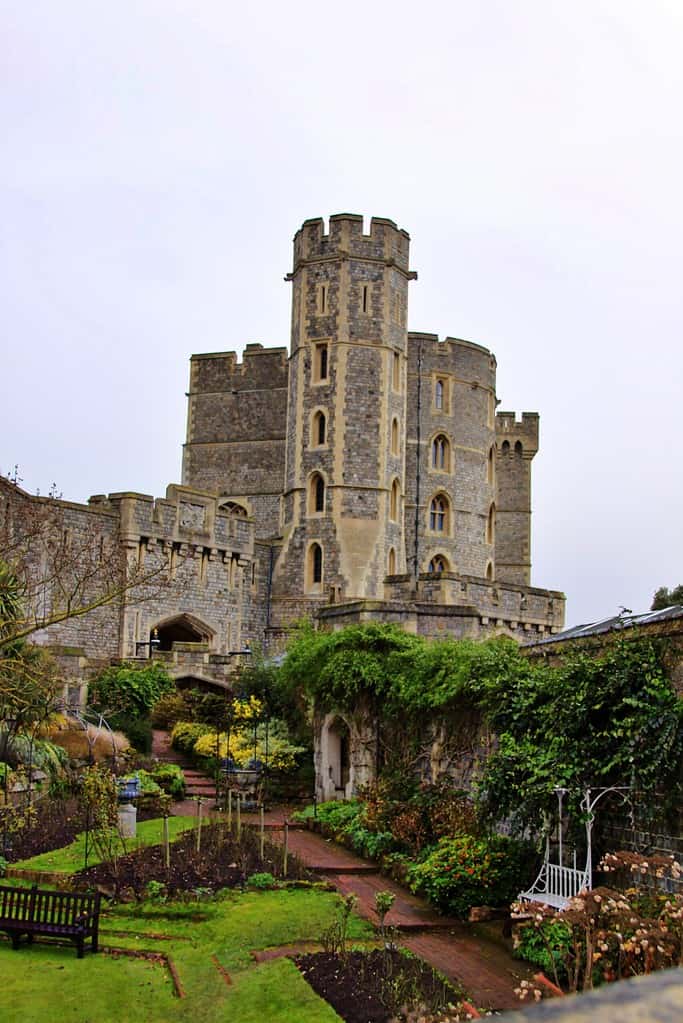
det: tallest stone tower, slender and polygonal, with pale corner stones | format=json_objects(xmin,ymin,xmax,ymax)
[{"xmin": 274, "ymin": 214, "xmax": 416, "ymax": 603}]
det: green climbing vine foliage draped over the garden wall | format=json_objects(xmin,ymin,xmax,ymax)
[{"xmin": 281, "ymin": 625, "xmax": 683, "ymax": 829}]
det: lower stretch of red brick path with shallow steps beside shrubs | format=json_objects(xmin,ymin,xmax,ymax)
[{"xmin": 272, "ymin": 814, "xmax": 532, "ymax": 1011}]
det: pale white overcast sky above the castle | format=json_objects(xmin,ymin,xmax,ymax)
[{"xmin": 0, "ymin": 0, "xmax": 683, "ymax": 625}]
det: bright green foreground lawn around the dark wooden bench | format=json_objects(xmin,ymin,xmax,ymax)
[{"xmin": 0, "ymin": 888, "xmax": 372, "ymax": 1023}]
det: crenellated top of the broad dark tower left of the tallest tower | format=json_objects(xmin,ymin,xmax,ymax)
[{"xmin": 190, "ymin": 342, "xmax": 287, "ymax": 394}]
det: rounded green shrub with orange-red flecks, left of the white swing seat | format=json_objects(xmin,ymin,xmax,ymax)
[{"xmin": 408, "ymin": 835, "xmax": 533, "ymax": 918}]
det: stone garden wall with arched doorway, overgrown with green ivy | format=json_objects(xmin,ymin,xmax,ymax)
[{"xmin": 281, "ymin": 625, "xmax": 683, "ymax": 836}]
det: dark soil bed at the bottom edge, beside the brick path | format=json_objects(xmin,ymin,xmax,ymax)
[{"xmin": 294, "ymin": 948, "xmax": 462, "ymax": 1023}]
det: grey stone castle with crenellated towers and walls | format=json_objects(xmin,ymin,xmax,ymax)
[{"xmin": 0, "ymin": 214, "xmax": 564, "ymax": 684}]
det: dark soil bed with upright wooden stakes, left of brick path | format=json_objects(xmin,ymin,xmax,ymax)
[{"xmin": 73, "ymin": 824, "xmax": 316, "ymax": 898}]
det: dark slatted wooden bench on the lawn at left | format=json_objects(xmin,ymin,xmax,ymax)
[{"xmin": 0, "ymin": 885, "xmax": 101, "ymax": 959}]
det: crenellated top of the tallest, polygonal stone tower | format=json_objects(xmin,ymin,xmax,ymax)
[{"xmin": 292, "ymin": 213, "xmax": 410, "ymax": 274}]
